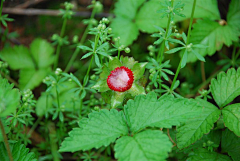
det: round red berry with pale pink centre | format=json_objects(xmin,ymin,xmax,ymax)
[{"xmin": 107, "ymin": 66, "xmax": 134, "ymax": 92}]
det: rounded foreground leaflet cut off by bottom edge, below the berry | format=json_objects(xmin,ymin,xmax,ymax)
[{"xmin": 114, "ymin": 130, "xmax": 172, "ymax": 161}]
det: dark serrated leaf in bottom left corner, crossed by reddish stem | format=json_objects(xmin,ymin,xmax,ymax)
[{"xmin": 0, "ymin": 142, "xmax": 37, "ymax": 161}]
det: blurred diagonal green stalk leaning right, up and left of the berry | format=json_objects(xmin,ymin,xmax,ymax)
[{"xmin": 64, "ymin": 8, "xmax": 96, "ymax": 72}]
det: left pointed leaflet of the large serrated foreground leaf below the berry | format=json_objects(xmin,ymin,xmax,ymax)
[{"xmin": 59, "ymin": 109, "xmax": 128, "ymax": 152}]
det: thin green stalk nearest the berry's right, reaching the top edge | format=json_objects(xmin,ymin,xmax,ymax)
[{"xmin": 157, "ymin": 0, "xmax": 174, "ymax": 95}]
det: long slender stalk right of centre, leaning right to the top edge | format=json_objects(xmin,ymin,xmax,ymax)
[{"xmin": 170, "ymin": 0, "xmax": 197, "ymax": 91}]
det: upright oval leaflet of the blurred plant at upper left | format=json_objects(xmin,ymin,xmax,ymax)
[{"xmin": 30, "ymin": 39, "xmax": 55, "ymax": 68}]
